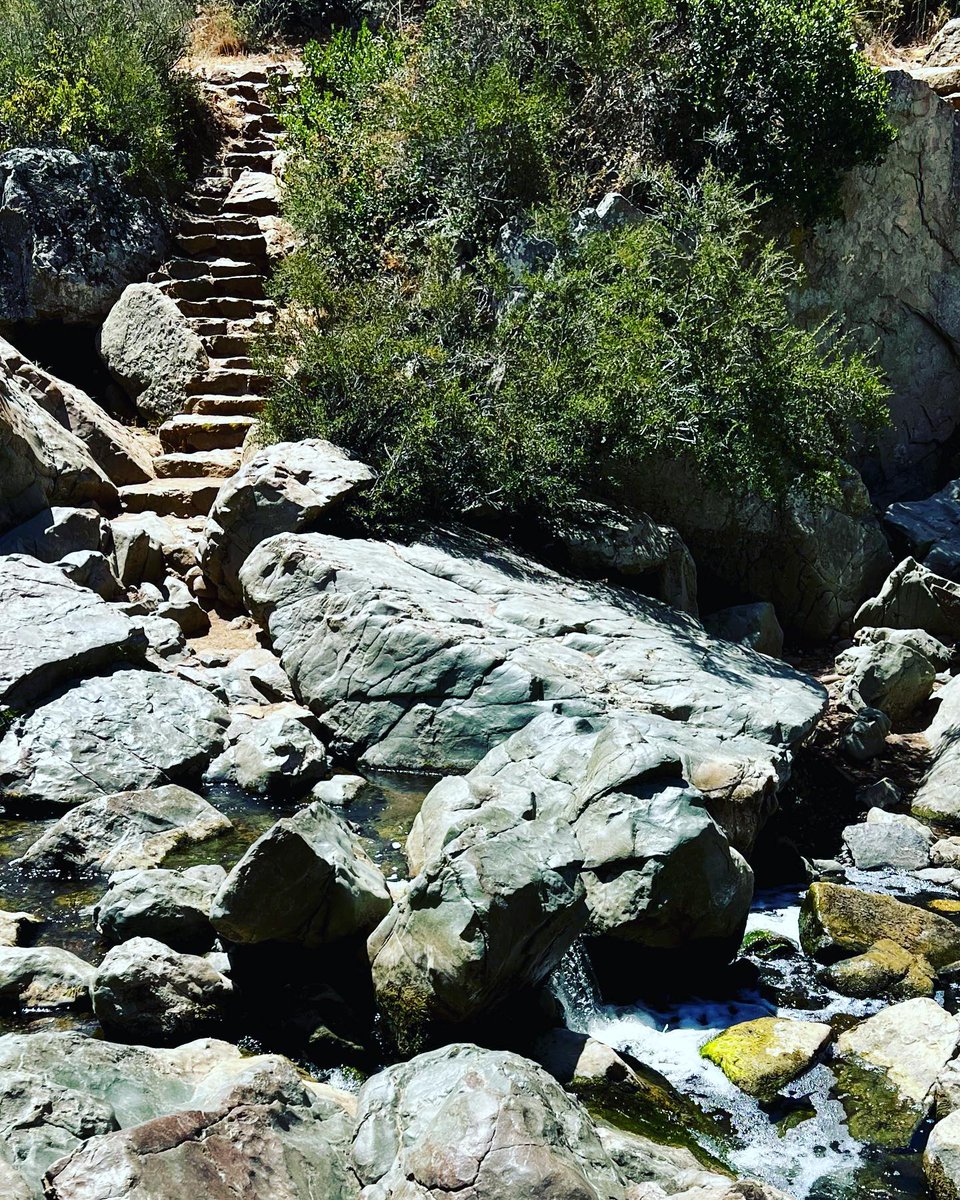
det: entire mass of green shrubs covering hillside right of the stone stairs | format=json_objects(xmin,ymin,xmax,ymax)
[{"xmin": 263, "ymin": 0, "xmax": 892, "ymax": 535}]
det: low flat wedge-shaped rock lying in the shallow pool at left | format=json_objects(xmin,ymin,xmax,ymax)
[{"xmin": 19, "ymin": 785, "xmax": 233, "ymax": 875}]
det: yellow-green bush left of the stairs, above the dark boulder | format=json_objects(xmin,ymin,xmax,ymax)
[{"xmin": 0, "ymin": 0, "xmax": 191, "ymax": 186}]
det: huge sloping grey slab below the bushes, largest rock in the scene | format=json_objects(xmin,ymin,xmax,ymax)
[{"xmin": 241, "ymin": 534, "xmax": 824, "ymax": 769}]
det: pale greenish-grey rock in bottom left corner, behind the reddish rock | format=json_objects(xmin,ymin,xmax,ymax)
[{"xmin": 0, "ymin": 1032, "xmax": 338, "ymax": 1200}]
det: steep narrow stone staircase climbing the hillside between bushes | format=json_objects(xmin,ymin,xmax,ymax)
[{"xmin": 120, "ymin": 62, "xmax": 298, "ymax": 517}]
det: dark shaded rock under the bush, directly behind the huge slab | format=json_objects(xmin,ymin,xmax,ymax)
[{"xmin": 551, "ymin": 503, "xmax": 697, "ymax": 617}]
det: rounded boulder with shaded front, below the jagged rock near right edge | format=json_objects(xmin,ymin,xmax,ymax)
[{"xmin": 836, "ymin": 630, "xmax": 947, "ymax": 726}]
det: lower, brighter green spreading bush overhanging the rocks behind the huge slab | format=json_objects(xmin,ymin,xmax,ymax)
[{"xmin": 260, "ymin": 172, "xmax": 884, "ymax": 524}]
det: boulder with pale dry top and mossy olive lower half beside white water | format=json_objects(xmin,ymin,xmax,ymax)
[{"xmin": 835, "ymin": 1000, "xmax": 960, "ymax": 1147}]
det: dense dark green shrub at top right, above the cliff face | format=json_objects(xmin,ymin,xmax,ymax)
[{"xmin": 671, "ymin": 0, "xmax": 893, "ymax": 220}]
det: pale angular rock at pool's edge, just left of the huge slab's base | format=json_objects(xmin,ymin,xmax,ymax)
[{"xmin": 206, "ymin": 703, "xmax": 329, "ymax": 796}]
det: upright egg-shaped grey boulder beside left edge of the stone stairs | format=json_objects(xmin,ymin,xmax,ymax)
[{"xmin": 100, "ymin": 283, "xmax": 210, "ymax": 424}]
